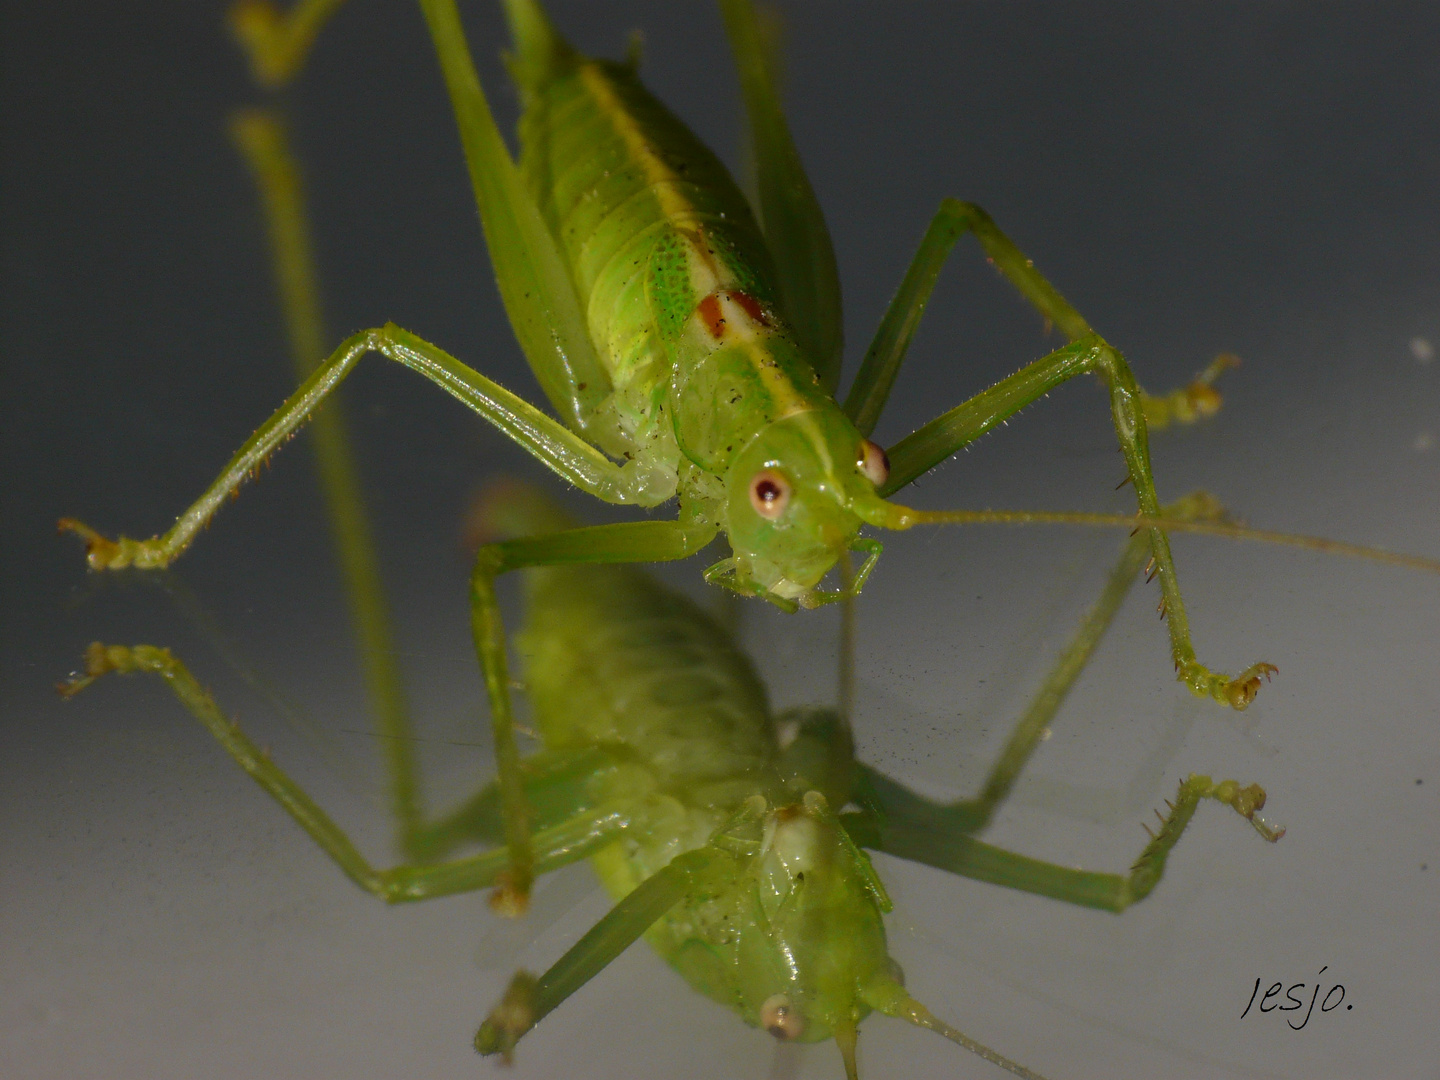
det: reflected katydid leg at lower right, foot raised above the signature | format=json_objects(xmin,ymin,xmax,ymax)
[{"xmin": 842, "ymin": 773, "xmax": 1284, "ymax": 912}]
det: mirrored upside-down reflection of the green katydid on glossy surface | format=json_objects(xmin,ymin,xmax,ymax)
[{"xmin": 65, "ymin": 485, "xmax": 1283, "ymax": 1080}]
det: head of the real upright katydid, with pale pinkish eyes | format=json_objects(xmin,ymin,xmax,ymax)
[{"xmin": 724, "ymin": 409, "xmax": 890, "ymax": 603}]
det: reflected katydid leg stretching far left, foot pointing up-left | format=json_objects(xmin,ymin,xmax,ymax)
[{"xmin": 59, "ymin": 642, "xmax": 631, "ymax": 903}]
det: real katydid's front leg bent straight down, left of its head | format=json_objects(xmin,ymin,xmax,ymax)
[{"xmin": 469, "ymin": 521, "xmax": 716, "ymax": 914}]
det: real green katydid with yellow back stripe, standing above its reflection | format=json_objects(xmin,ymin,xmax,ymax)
[{"xmin": 56, "ymin": 0, "xmax": 1433, "ymax": 907}]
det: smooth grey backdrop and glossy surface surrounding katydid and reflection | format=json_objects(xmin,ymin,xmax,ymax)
[{"xmin": 0, "ymin": 0, "xmax": 1440, "ymax": 1079}]
